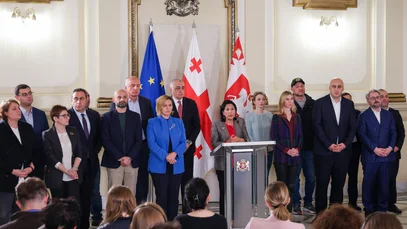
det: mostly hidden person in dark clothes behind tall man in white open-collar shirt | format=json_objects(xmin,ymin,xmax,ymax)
[{"xmin": 342, "ymin": 92, "xmax": 362, "ymax": 211}]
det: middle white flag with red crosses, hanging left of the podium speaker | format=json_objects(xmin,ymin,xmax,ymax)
[{"xmin": 183, "ymin": 29, "xmax": 214, "ymax": 177}]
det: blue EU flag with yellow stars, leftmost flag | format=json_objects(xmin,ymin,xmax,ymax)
[{"xmin": 140, "ymin": 32, "xmax": 165, "ymax": 114}]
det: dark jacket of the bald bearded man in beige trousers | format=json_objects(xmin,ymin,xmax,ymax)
[{"xmin": 101, "ymin": 109, "xmax": 142, "ymax": 168}]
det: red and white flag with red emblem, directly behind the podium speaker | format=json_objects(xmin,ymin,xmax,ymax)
[{"xmin": 225, "ymin": 36, "xmax": 252, "ymax": 118}]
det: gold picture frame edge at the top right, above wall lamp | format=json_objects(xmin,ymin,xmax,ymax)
[{"xmin": 293, "ymin": 0, "xmax": 358, "ymax": 10}]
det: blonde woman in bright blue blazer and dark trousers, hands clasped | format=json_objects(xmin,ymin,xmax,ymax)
[{"xmin": 147, "ymin": 95, "xmax": 186, "ymax": 221}]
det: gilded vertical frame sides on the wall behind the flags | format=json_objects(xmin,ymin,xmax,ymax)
[{"xmin": 128, "ymin": 0, "xmax": 238, "ymax": 76}]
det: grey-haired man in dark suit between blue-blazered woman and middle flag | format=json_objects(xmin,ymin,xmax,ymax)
[{"xmin": 170, "ymin": 79, "xmax": 201, "ymax": 213}]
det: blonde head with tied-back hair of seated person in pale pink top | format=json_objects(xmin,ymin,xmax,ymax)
[{"xmin": 264, "ymin": 181, "xmax": 291, "ymax": 221}]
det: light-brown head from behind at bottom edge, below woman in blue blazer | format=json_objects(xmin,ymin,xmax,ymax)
[{"xmin": 130, "ymin": 202, "xmax": 167, "ymax": 229}]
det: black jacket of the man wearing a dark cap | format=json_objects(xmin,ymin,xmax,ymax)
[{"xmin": 294, "ymin": 94, "xmax": 315, "ymax": 150}]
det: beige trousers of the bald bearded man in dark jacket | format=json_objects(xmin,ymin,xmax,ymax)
[{"xmin": 107, "ymin": 165, "xmax": 138, "ymax": 194}]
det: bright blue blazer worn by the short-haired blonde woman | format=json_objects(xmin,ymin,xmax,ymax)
[{"xmin": 147, "ymin": 116, "xmax": 187, "ymax": 174}]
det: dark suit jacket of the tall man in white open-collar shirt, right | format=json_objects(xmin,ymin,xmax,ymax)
[{"xmin": 313, "ymin": 95, "xmax": 356, "ymax": 155}]
